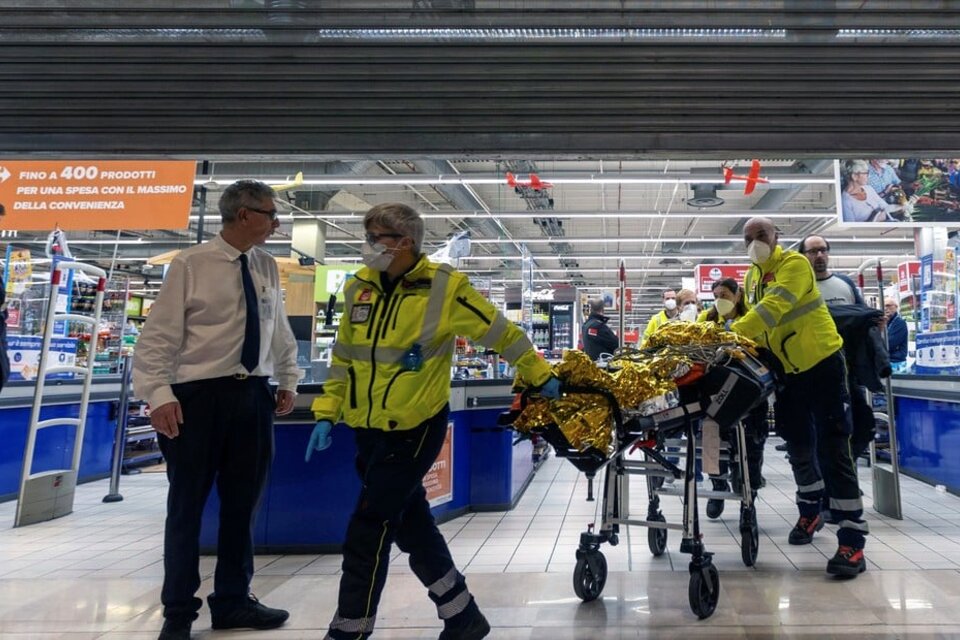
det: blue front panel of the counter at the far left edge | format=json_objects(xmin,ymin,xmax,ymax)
[{"xmin": 0, "ymin": 402, "xmax": 116, "ymax": 500}]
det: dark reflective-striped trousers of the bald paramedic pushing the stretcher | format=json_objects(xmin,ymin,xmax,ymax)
[{"xmin": 777, "ymin": 351, "xmax": 869, "ymax": 549}]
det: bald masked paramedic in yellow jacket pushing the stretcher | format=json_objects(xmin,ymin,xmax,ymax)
[{"xmin": 731, "ymin": 218, "xmax": 868, "ymax": 577}]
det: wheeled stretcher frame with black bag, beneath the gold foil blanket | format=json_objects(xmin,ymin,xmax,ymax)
[{"xmin": 505, "ymin": 346, "xmax": 774, "ymax": 619}]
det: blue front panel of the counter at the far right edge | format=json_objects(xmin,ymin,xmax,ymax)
[{"xmin": 895, "ymin": 397, "xmax": 960, "ymax": 493}]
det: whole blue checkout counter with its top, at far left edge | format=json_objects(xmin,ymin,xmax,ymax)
[{"xmin": 0, "ymin": 375, "xmax": 121, "ymax": 502}]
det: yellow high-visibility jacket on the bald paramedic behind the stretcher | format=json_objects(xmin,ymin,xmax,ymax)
[{"xmin": 731, "ymin": 246, "xmax": 843, "ymax": 373}]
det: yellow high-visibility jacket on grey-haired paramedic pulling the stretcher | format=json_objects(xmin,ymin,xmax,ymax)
[{"xmin": 311, "ymin": 256, "xmax": 550, "ymax": 431}]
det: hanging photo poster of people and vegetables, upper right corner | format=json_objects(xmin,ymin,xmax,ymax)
[{"xmin": 834, "ymin": 159, "xmax": 960, "ymax": 227}]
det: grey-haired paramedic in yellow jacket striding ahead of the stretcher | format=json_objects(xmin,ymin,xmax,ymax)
[{"xmin": 307, "ymin": 204, "xmax": 559, "ymax": 640}]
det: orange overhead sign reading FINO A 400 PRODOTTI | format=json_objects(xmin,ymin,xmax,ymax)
[{"xmin": 0, "ymin": 160, "xmax": 196, "ymax": 231}]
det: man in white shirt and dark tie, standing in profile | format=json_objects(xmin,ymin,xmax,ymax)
[{"xmin": 133, "ymin": 180, "xmax": 299, "ymax": 640}]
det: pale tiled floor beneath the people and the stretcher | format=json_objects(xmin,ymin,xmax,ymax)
[{"xmin": 0, "ymin": 439, "xmax": 960, "ymax": 640}]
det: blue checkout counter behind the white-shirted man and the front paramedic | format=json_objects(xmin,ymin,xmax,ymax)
[{"xmin": 200, "ymin": 379, "xmax": 535, "ymax": 553}]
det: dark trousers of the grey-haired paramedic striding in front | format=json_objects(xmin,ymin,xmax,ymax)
[{"xmin": 329, "ymin": 407, "xmax": 476, "ymax": 640}]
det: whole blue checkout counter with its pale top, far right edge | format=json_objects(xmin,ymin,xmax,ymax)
[{"xmin": 892, "ymin": 374, "xmax": 960, "ymax": 495}]
